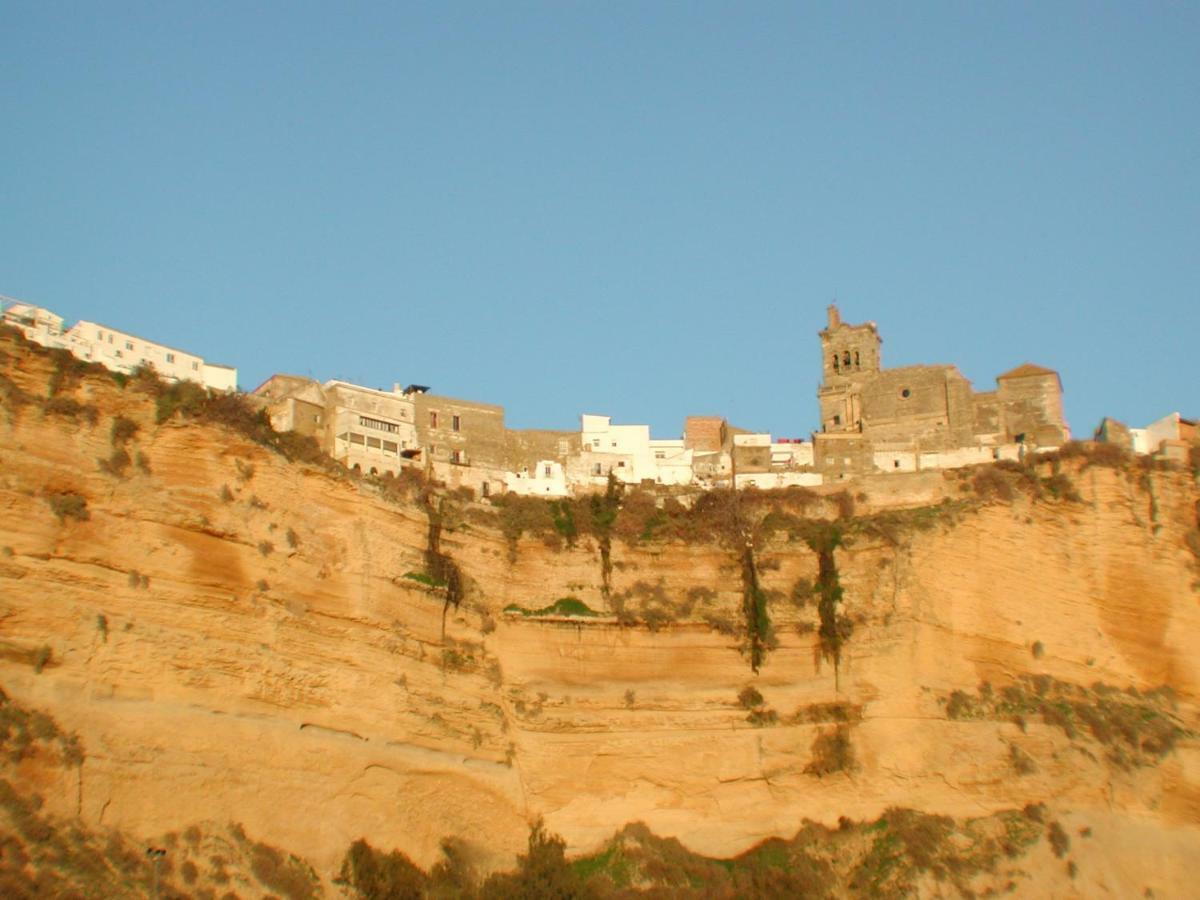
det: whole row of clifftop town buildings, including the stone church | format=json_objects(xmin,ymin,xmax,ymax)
[{"xmin": 2, "ymin": 301, "xmax": 1198, "ymax": 498}]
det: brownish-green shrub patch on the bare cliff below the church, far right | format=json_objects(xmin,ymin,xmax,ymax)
[{"xmin": 944, "ymin": 674, "xmax": 1189, "ymax": 769}]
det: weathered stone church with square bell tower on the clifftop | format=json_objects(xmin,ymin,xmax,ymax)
[{"xmin": 814, "ymin": 306, "xmax": 1070, "ymax": 478}]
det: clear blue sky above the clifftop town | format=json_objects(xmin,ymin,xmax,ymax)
[{"xmin": 0, "ymin": 0, "xmax": 1200, "ymax": 437}]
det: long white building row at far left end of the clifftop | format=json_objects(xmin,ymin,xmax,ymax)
[{"xmin": 4, "ymin": 302, "xmax": 238, "ymax": 391}]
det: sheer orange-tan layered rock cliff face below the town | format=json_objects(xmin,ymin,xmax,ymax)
[{"xmin": 0, "ymin": 337, "xmax": 1200, "ymax": 896}]
